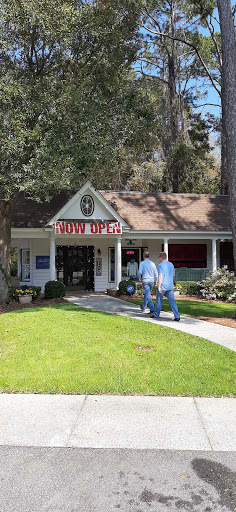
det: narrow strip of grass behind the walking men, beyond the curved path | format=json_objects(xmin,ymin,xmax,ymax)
[{"xmin": 128, "ymin": 298, "xmax": 235, "ymax": 318}]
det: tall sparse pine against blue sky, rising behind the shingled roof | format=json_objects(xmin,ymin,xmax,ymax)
[{"xmin": 137, "ymin": 0, "xmax": 218, "ymax": 192}]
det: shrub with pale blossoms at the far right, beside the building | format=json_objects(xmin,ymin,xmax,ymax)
[{"xmin": 199, "ymin": 266, "xmax": 236, "ymax": 302}]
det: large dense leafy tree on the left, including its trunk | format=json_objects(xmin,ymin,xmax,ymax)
[{"xmin": 0, "ymin": 0, "xmax": 144, "ymax": 301}]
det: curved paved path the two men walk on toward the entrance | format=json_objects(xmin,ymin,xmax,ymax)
[{"xmin": 66, "ymin": 295, "xmax": 236, "ymax": 352}]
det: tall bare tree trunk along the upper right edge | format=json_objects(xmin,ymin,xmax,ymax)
[{"xmin": 217, "ymin": 0, "xmax": 236, "ymax": 276}]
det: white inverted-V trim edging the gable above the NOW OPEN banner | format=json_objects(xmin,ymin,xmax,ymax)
[{"xmin": 46, "ymin": 181, "xmax": 127, "ymax": 227}]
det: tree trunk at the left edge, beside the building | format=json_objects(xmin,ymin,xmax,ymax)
[{"xmin": 0, "ymin": 199, "xmax": 12, "ymax": 303}]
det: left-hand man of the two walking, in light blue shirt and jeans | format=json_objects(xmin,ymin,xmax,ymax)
[{"xmin": 138, "ymin": 251, "xmax": 157, "ymax": 314}]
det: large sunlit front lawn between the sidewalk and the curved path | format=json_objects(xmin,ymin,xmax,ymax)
[{"xmin": 0, "ymin": 304, "xmax": 236, "ymax": 396}]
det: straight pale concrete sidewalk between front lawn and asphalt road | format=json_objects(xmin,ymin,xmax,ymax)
[{"xmin": 0, "ymin": 394, "xmax": 236, "ymax": 452}]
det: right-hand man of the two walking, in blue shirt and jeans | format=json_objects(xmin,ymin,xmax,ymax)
[{"xmin": 150, "ymin": 252, "xmax": 180, "ymax": 322}]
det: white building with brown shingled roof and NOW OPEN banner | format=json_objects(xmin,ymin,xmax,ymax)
[{"xmin": 12, "ymin": 182, "xmax": 233, "ymax": 291}]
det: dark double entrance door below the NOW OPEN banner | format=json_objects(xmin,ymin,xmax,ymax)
[{"xmin": 57, "ymin": 246, "xmax": 94, "ymax": 290}]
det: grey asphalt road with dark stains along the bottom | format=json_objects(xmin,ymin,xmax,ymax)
[{"xmin": 0, "ymin": 446, "xmax": 236, "ymax": 512}]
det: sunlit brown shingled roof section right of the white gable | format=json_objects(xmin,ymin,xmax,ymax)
[{"xmin": 103, "ymin": 192, "xmax": 231, "ymax": 231}]
